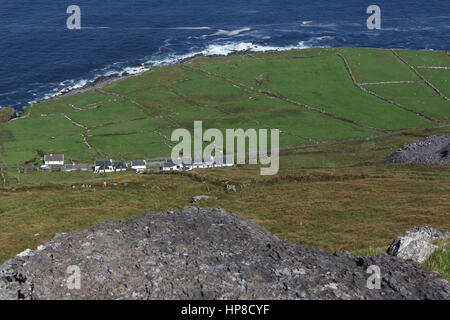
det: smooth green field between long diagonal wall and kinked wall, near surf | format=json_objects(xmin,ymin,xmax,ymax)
[{"xmin": 201, "ymin": 56, "xmax": 429, "ymax": 129}]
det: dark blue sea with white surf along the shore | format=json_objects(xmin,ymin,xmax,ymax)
[{"xmin": 0, "ymin": 0, "xmax": 450, "ymax": 110}]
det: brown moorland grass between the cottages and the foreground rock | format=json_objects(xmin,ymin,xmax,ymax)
[{"xmin": 0, "ymin": 160, "xmax": 450, "ymax": 261}]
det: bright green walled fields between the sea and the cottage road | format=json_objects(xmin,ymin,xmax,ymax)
[{"xmin": 0, "ymin": 48, "xmax": 450, "ymax": 165}]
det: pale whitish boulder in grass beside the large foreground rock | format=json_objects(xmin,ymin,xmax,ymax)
[{"xmin": 387, "ymin": 227, "xmax": 450, "ymax": 263}]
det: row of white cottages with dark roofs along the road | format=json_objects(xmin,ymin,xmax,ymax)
[{"xmin": 41, "ymin": 154, "xmax": 234, "ymax": 173}]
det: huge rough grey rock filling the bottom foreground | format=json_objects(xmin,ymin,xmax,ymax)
[{"xmin": 0, "ymin": 207, "xmax": 450, "ymax": 299}]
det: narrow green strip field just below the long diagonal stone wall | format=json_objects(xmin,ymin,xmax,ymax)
[{"xmin": 169, "ymin": 74, "xmax": 374, "ymax": 141}]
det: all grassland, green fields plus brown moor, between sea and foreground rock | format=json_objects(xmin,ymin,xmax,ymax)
[{"xmin": 0, "ymin": 48, "xmax": 450, "ymax": 277}]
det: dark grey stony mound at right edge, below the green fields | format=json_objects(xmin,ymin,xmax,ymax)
[{"xmin": 385, "ymin": 134, "xmax": 450, "ymax": 165}]
